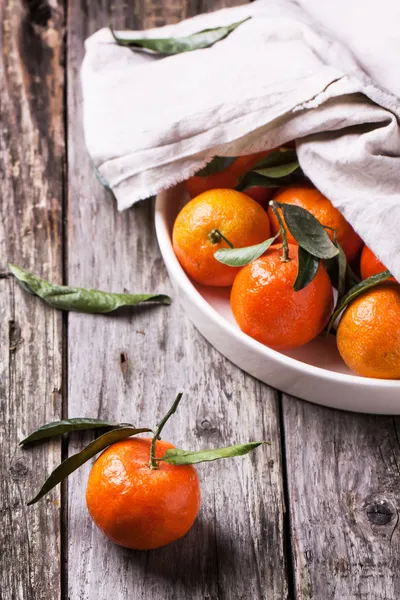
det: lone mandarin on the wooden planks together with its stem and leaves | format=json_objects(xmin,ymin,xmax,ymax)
[{"xmin": 25, "ymin": 393, "xmax": 267, "ymax": 550}]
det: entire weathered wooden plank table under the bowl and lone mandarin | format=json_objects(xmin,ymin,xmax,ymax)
[{"xmin": 0, "ymin": 0, "xmax": 400, "ymax": 600}]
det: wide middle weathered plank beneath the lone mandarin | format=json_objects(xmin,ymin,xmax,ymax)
[{"xmin": 68, "ymin": 0, "xmax": 287, "ymax": 600}]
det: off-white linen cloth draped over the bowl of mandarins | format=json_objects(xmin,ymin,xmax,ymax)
[{"xmin": 81, "ymin": 0, "xmax": 400, "ymax": 281}]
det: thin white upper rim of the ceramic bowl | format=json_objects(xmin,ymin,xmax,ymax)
[{"xmin": 155, "ymin": 188, "xmax": 400, "ymax": 392}]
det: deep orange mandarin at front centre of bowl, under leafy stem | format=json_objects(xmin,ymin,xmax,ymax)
[{"xmin": 231, "ymin": 244, "xmax": 333, "ymax": 350}]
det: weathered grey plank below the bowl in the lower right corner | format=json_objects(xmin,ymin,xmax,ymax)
[{"xmin": 283, "ymin": 397, "xmax": 400, "ymax": 600}]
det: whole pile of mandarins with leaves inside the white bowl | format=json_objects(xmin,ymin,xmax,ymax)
[{"xmin": 172, "ymin": 148, "xmax": 400, "ymax": 379}]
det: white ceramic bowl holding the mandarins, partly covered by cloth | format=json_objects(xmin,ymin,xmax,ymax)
[{"xmin": 155, "ymin": 186, "xmax": 400, "ymax": 414}]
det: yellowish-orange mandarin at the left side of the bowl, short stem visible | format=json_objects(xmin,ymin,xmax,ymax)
[{"xmin": 172, "ymin": 189, "xmax": 270, "ymax": 286}]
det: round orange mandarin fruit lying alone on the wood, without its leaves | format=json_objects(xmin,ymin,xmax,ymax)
[{"xmin": 86, "ymin": 438, "xmax": 200, "ymax": 550}]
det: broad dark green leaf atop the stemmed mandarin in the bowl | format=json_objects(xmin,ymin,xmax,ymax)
[{"xmin": 279, "ymin": 204, "xmax": 339, "ymax": 258}]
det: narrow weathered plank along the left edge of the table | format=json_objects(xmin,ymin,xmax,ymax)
[{"xmin": 0, "ymin": 0, "xmax": 64, "ymax": 600}]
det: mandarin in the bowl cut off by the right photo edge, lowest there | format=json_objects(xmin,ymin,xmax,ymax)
[{"xmin": 336, "ymin": 282, "xmax": 400, "ymax": 379}]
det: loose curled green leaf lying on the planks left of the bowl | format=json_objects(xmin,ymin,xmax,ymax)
[{"xmin": 9, "ymin": 264, "xmax": 171, "ymax": 314}]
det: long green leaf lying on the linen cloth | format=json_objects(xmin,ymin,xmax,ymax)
[{"xmin": 110, "ymin": 17, "xmax": 250, "ymax": 56}]
